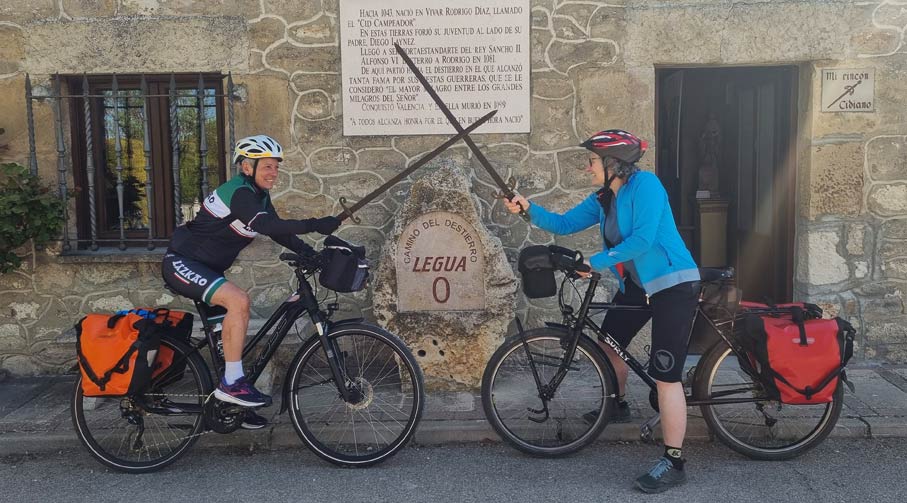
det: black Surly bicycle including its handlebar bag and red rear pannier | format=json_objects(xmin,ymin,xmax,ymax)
[{"xmin": 482, "ymin": 246, "xmax": 855, "ymax": 460}]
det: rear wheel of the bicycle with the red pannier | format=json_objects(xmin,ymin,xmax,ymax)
[{"xmin": 693, "ymin": 343, "xmax": 844, "ymax": 460}]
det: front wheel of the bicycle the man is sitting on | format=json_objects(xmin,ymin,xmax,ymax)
[{"xmin": 285, "ymin": 324, "xmax": 425, "ymax": 467}]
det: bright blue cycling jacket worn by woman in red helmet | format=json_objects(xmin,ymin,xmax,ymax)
[{"xmin": 529, "ymin": 171, "xmax": 699, "ymax": 295}]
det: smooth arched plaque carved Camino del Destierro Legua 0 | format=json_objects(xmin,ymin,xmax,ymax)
[{"xmin": 396, "ymin": 211, "xmax": 485, "ymax": 312}]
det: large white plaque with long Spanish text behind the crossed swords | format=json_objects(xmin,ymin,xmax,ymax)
[{"xmin": 340, "ymin": 0, "xmax": 530, "ymax": 136}]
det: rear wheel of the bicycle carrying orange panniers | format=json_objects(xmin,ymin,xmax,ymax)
[{"xmin": 71, "ymin": 337, "xmax": 212, "ymax": 473}]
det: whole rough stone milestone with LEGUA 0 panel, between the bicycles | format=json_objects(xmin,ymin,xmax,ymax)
[{"xmin": 372, "ymin": 166, "xmax": 517, "ymax": 389}]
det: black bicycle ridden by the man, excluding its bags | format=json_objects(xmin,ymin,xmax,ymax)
[{"xmin": 72, "ymin": 246, "xmax": 425, "ymax": 473}]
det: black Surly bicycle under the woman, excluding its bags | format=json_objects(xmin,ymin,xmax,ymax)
[{"xmin": 482, "ymin": 246, "xmax": 843, "ymax": 460}]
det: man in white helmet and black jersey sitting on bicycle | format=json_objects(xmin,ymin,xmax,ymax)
[{"xmin": 161, "ymin": 135, "xmax": 340, "ymax": 429}]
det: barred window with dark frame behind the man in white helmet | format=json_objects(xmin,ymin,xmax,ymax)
[{"xmin": 64, "ymin": 74, "xmax": 232, "ymax": 250}]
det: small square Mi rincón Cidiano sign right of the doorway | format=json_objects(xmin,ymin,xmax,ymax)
[{"xmin": 821, "ymin": 68, "xmax": 875, "ymax": 112}]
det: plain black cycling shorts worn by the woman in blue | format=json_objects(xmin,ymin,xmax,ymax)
[{"xmin": 602, "ymin": 280, "xmax": 700, "ymax": 382}]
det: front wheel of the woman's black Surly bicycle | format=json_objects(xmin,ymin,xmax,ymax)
[{"xmin": 482, "ymin": 328, "xmax": 617, "ymax": 456}]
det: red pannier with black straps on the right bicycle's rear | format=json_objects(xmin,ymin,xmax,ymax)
[{"xmin": 740, "ymin": 303, "xmax": 855, "ymax": 405}]
